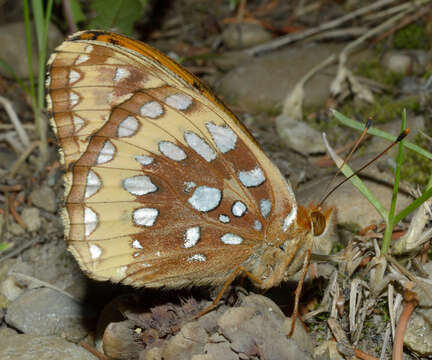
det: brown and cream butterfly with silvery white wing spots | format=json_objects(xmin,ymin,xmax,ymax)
[{"xmin": 46, "ymin": 31, "xmax": 332, "ymax": 312}]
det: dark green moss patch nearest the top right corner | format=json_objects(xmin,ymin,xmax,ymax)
[{"xmin": 393, "ymin": 24, "xmax": 431, "ymax": 49}]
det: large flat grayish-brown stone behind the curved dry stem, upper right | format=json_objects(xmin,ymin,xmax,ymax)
[{"xmin": 217, "ymin": 43, "xmax": 371, "ymax": 111}]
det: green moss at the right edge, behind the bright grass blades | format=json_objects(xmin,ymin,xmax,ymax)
[{"xmin": 401, "ymin": 134, "xmax": 432, "ymax": 185}]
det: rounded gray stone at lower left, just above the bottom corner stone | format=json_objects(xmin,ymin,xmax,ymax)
[{"xmin": 5, "ymin": 288, "xmax": 96, "ymax": 342}]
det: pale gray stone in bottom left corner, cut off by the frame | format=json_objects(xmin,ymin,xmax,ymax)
[{"xmin": 0, "ymin": 331, "xmax": 97, "ymax": 360}]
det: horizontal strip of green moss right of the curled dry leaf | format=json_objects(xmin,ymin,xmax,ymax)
[{"xmin": 340, "ymin": 95, "xmax": 420, "ymax": 124}]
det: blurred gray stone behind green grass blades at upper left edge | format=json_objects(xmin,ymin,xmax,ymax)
[{"xmin": 0, "ymin": 22, "xmax": 64, "ymax": 79}]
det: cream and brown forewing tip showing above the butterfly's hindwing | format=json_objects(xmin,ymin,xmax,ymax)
[{"xmin": 47, "ymin": 42, "xmax": 165, "ymax": 167}]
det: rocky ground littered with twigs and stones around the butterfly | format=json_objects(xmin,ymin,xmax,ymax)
[{"xmin": 0, "ymin": 0, "xmax": 432, "ymax": 360}]
